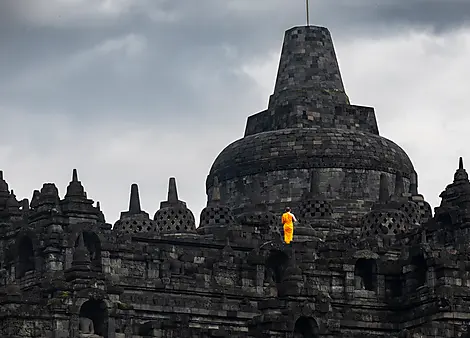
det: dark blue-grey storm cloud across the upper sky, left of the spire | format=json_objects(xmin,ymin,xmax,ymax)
[{"xmin": 0, "ymin": 0, "xmax": 470, "ymax": 128}]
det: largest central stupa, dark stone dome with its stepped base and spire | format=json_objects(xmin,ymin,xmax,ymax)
[{"xmin": 206, "ymin": 26, "xmax": 415, "ymax": 217}]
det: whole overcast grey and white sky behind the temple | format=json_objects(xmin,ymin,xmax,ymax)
[{"xmin": 0, "ymin": 0, "xmax": 470, "ymax": 223}]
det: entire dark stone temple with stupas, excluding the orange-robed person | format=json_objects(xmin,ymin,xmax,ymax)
[{"xmin": 0, "ymin": 26, "xmax": 470, "ymax": 338}]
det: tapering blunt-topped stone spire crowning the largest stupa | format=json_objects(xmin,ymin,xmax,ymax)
[{"xmin": 270, "ymin": 26, "xmax": 348, "ymax": 105}]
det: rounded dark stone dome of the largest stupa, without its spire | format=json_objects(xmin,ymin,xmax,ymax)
[{"xmin": 206, "ymin": 117, "xmax": 414, "ymax": 217}]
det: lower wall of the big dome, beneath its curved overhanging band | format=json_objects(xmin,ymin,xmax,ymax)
[{"xmin": 209, "ymin": 168, "xmax": 409, "ymax": 218}]
